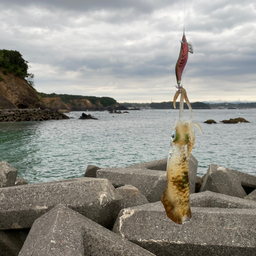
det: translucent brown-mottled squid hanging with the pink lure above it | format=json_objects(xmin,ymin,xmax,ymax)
[{"xmin": 161, "ymin": 33, "xmax": 202, "ymax": 224}]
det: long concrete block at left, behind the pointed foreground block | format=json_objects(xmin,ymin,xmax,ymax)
[{"xmin": 0, "ymin": 178, "xmax": 122, "ymax": 230}]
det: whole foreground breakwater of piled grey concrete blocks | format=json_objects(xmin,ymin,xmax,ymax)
[{"xmin": 0, "ymin": 155, "xmax": 256, "ymax": 256}]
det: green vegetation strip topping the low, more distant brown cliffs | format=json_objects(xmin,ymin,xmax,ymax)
[{"xmin": 39, "ymin": 92, "xmax": 117, "ymax": 107}]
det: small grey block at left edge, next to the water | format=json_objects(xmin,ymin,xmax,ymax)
[{"xmin": 0, "ymin": 161, "xmax": 18, "ymax": 188}]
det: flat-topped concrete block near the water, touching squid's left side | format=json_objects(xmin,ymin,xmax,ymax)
[{"xmin": 97, "ymin": 168, "xmax": 167, "ymax": 202}]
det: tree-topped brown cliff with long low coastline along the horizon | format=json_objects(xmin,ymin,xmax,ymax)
[{"xmin": 0, "ymin": 50, "xmax": 256, "ymax": 112}]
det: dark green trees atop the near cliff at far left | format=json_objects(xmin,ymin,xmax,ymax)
[{"xmin": 0, "ymin": 50, "xmax": 34, "ymax": 86}]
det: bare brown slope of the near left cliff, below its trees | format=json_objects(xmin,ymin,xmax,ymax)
[{"xmin": 0, "ymin": 68, "xmax": 44, "ymax": 109}]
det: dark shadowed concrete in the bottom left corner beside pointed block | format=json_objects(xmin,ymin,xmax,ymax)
[{"xmin": 0, "ymin": 229, "xmax": 29, "ymax": 256}]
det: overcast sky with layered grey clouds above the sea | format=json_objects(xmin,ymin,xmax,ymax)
[{"xmin": 0, "ymin": 0, "xmax": 256, "ymax": 102}]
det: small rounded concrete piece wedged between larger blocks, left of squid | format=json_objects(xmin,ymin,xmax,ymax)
[{"xmin": 116, "ymin": 185, "xmax": 148, "ymax": 208}]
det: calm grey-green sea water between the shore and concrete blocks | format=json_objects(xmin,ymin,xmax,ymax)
[{"xmin": 0, "ymin": 109, "xmax": 256, "ymax": 183}]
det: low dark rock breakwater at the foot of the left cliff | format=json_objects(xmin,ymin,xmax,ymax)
[{"xmin": 0, "ymin": 109, "xmax": 69, "ymax": 122}]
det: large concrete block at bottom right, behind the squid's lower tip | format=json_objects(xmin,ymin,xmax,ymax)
[{"xmin": 113, "ymin": 202, "xmax": 256, "ymax": 256}]
